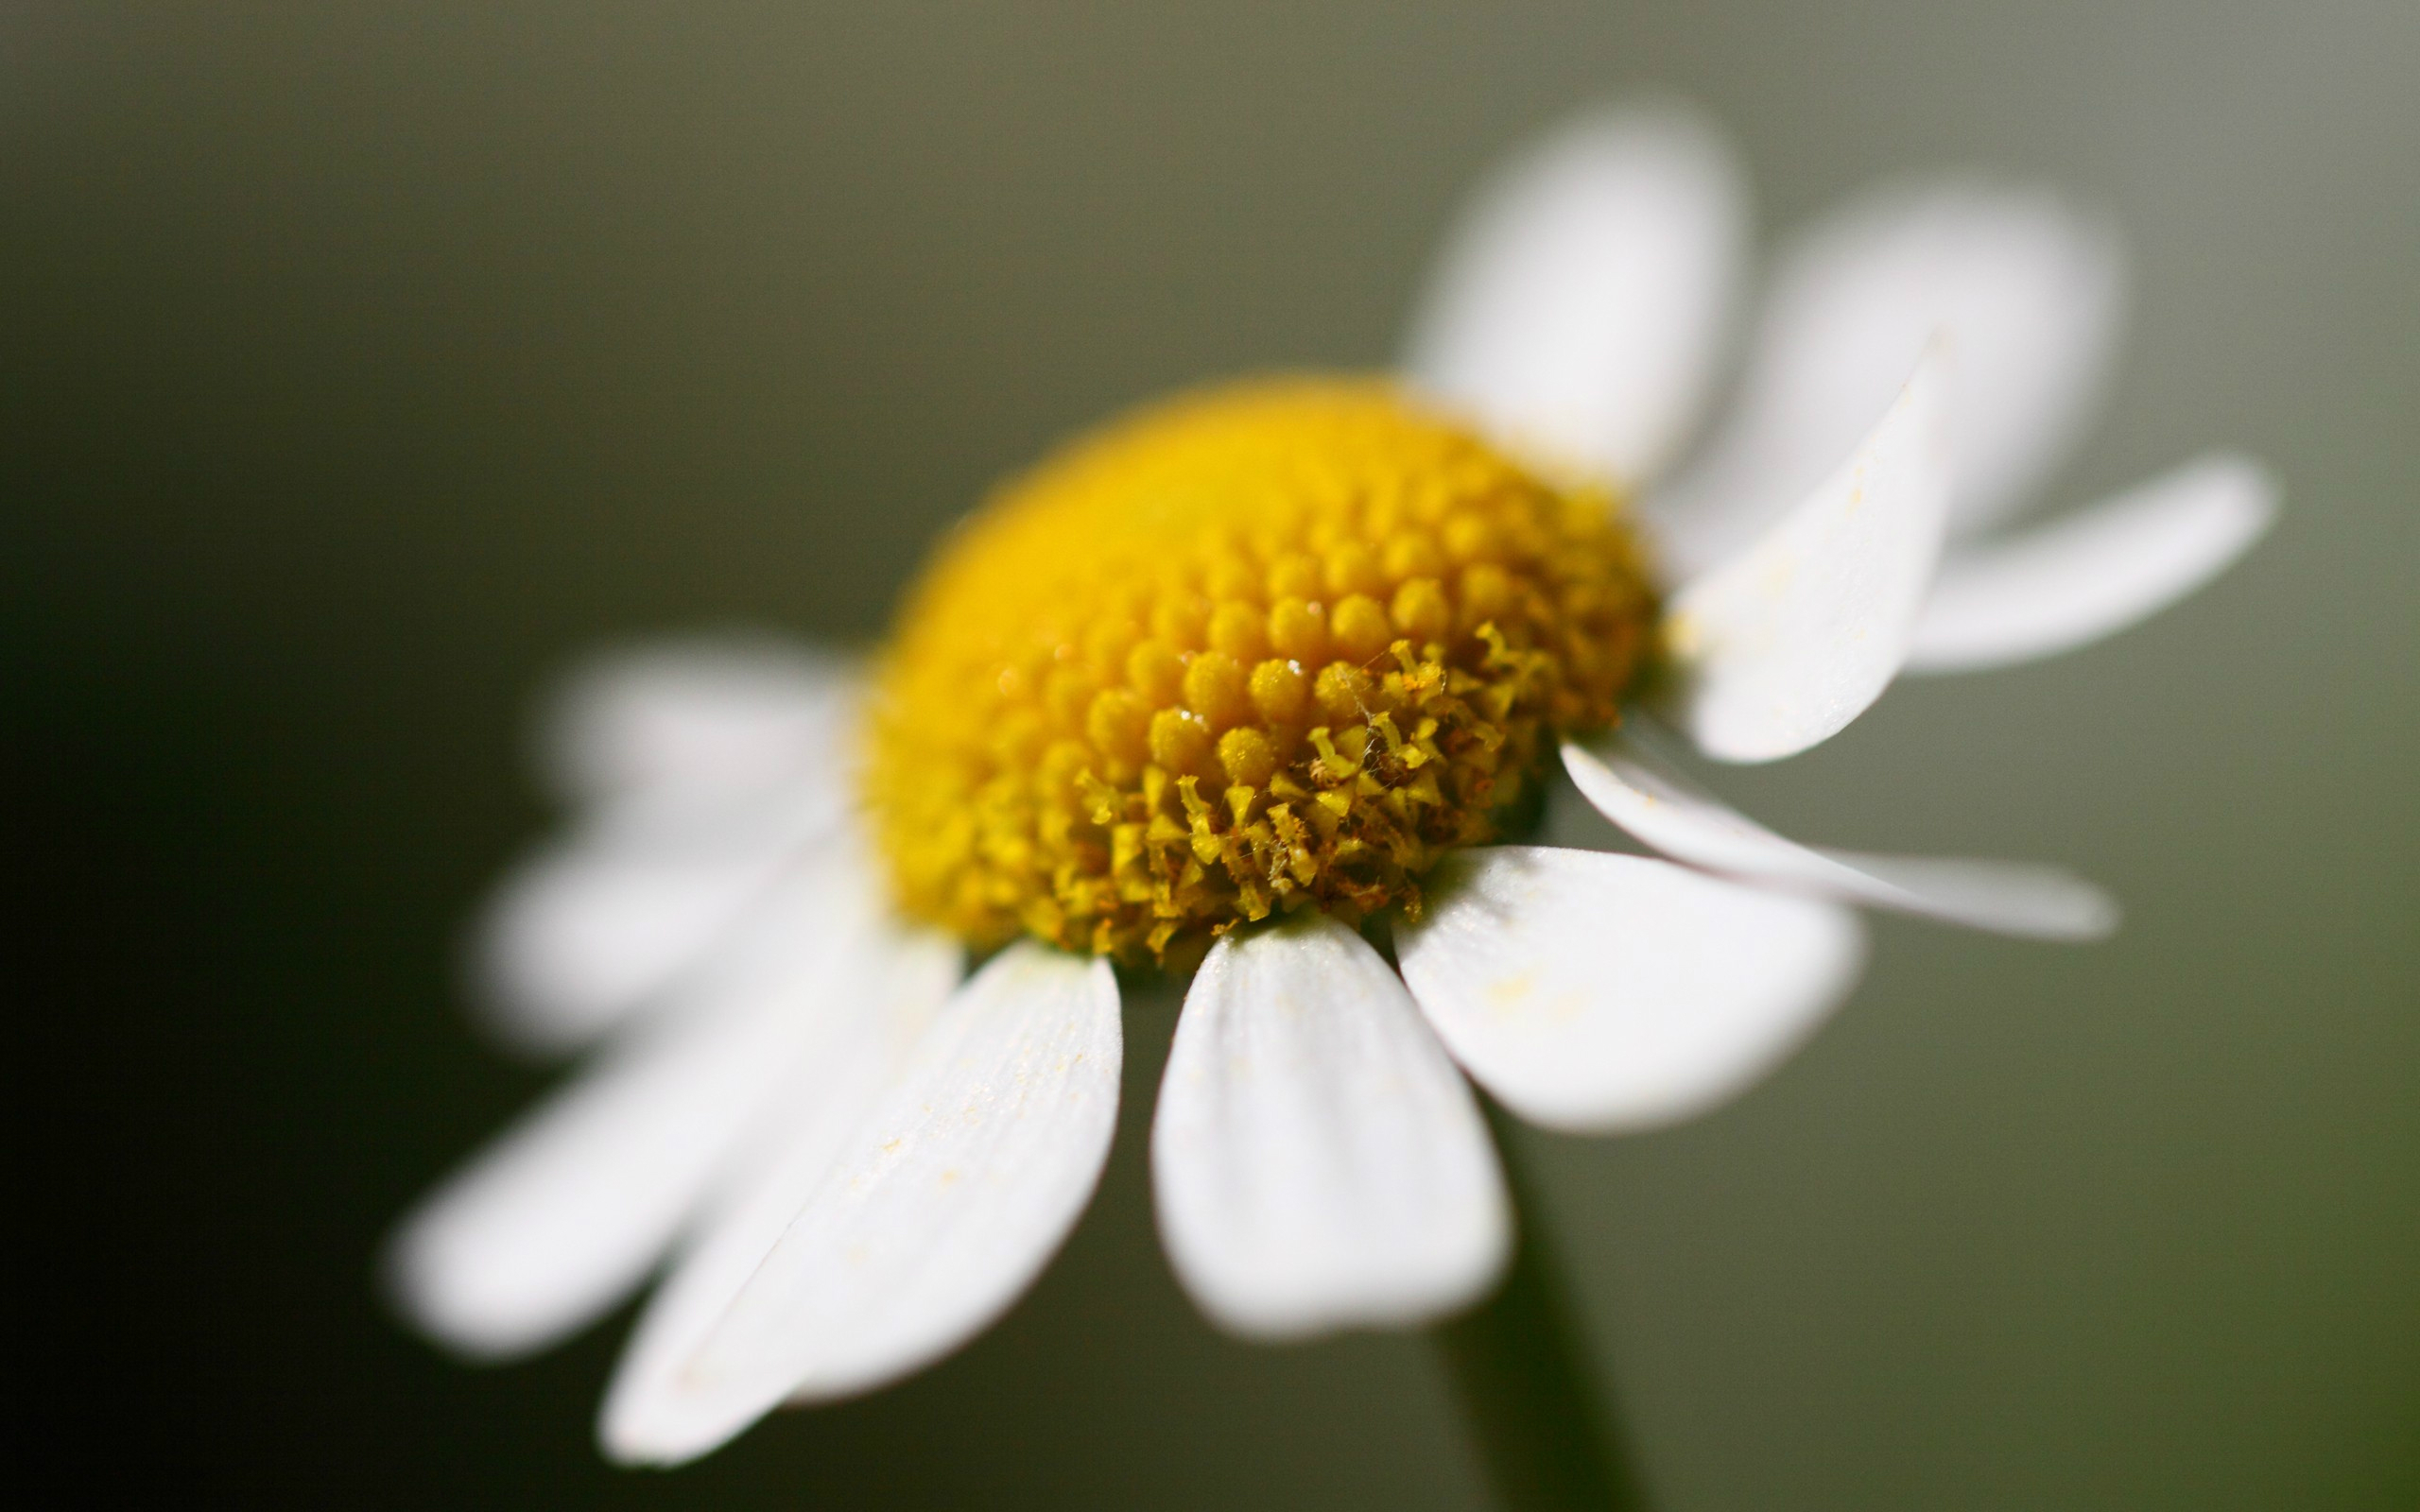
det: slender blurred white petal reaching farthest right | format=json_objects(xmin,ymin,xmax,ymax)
[{"xmin": 1907, "ymin": 455, "xmax": 2277, "ymax": 673}]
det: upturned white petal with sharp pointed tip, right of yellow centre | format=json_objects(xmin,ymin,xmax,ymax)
[{"xmin": 1665, "ymin": 355, "xmax": 1948, "ymax": 762}]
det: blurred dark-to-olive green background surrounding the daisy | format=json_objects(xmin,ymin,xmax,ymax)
[{"xmin": 0, "ymin": 0, "xmax": 2420, "ymax": 1509}]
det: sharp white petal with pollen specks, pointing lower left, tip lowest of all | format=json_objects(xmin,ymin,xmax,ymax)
[{"xmin": 613, "ymin": 943, "xmax": 1120, "ymax": 1464}]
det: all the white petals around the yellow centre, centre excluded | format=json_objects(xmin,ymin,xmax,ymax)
[{"xmin": 394, "ymin": 107, "xmax": 2273, "ymax": 1461}]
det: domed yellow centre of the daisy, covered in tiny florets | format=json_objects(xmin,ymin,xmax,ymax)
[{"xmin": 866, "ymin": 380, "xmax": 1655, "ymax": 960}]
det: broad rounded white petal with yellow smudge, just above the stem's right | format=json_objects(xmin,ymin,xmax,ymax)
[{"xmin": 1396, "ymin": 847, "xmax": 1863, "ymax": 1132}]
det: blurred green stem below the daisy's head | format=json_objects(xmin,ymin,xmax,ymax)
[{"xmin": 1433, "ymin": 1096, "xmax": 1648, "ymax": 1512}]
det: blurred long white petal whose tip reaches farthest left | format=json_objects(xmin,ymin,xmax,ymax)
[{"xmin": 389, "ymin": 861, "xmax": 900, "ymax": 1357}]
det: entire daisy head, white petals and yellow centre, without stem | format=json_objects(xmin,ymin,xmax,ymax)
[{"xmin": 392, "ymin": 94, "xmax": 2273, "ymax": 1464}]
